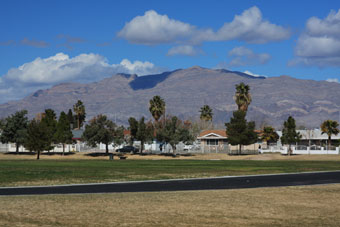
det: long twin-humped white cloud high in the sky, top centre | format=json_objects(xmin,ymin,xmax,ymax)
[{"xmin": 117, "ymin": 6, "xmax": 291, "ymax": 45}]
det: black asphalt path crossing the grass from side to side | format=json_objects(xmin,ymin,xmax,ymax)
[{"xmin": 0, "ymin": 171, "xmax": 340, "ymax": 196}]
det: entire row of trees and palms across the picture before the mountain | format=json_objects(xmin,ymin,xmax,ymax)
[{"xmin": 0, "ymin": 82, "xmax": 339, "ymax": 159}]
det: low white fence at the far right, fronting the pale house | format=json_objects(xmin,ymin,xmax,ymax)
[{"xmin": 260, "ymin": 146, "xmax": 340, "ymax": 155}]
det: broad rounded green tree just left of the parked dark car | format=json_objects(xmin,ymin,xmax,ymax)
[{"xmin": 83, "ymin": 115, "xmax": 124, "ymax": 154}]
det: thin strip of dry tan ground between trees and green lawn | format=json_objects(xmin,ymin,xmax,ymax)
[{"xmin": 0, "ymin": 152, "xmax": 340, "ymax": 161}]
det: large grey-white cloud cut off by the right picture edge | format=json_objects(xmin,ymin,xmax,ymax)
[{"xmin": 289, "ymin": 9, "xmax": 340, "ymax": 67}]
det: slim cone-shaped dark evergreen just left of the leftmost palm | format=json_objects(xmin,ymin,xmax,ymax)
[{"xmin": 54, "ymin": 111, "xmax": 73, "ymax": 155}]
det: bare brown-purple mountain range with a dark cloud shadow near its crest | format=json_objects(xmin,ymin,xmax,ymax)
[{"xmin": 0, "ymin": 66, "xmax": 340, "ymax": 128}]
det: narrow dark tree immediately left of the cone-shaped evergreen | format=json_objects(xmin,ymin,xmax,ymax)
[{"xmin": 41, "ymin": 109, "xmax": 57, "ymax": 152}]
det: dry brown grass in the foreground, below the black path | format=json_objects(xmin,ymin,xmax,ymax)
[{"xmin": 0, "ymin": 184, "xmax": 340, "ymax": 227}]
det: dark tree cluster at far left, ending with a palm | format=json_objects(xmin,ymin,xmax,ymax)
[{"xmin": 0, "ymin": 100, "xmax": 86, "ymax": 159}]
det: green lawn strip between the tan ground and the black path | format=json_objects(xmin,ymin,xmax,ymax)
[{"xmin": 0, "ymin": 159, "xmax": 340, "ymax": 186}]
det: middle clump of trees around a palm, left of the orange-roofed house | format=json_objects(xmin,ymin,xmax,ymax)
[{"xmin": 83, "ymin": 96, "xmax": 195, "ymax": 153}]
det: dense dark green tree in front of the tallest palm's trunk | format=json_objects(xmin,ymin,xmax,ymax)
[{"xmin": 225, "ymin": 110, "xmax": 258, "ymax": 154}]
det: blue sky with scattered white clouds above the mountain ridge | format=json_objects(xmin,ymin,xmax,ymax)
[{"xmin": 0, "ymin": 0, "xmax": 340, "ymax": 103}]
